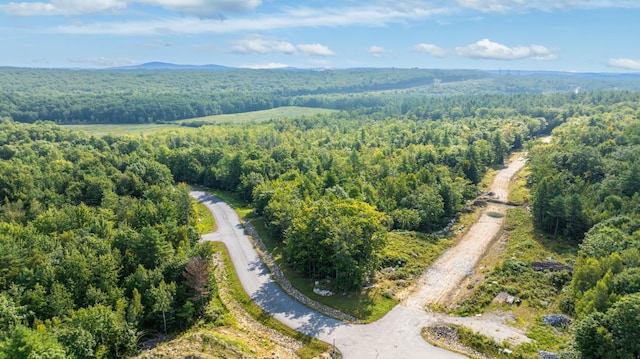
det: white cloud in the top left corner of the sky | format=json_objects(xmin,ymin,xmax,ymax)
[{"xmin": 0, "ymin": 0, "xmax": 127, "ymax": 16}]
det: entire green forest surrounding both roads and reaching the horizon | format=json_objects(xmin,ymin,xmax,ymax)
[{"xmin": 0, "ymin": 69, "xmax": 640, "ymax": 358}]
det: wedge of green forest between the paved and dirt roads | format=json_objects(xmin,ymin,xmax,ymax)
[{"xmin": 154, "ymin": 92, "xmax": 638, "ymax": 290}]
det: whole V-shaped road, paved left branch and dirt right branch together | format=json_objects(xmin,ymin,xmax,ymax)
[{"xmin": 191, "ymin": 154, "xmax": 524, "ymax": 359}]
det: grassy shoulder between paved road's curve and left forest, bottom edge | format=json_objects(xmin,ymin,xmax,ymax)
[{"xmin": 136, "ymin": 242, "xmax": 331, "ymax": 359}]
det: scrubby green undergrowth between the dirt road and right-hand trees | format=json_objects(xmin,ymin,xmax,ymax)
[{"xmin": 454, "ymin": 178, "xmax": 577, "ymax": 358}]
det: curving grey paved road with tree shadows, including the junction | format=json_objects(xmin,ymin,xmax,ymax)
[{"xmin": 191, "ymin": 191, "xmax": 466, "ymax": 359}]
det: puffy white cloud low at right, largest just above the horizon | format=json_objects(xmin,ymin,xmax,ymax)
[{"xmin": 455, "ymin": 39, "xmax": 558, "ymax": 60}]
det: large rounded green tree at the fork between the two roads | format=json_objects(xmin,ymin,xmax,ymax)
[{"xmin": 284, "ymin": 199, "xmax": 387, "ymax": 290}]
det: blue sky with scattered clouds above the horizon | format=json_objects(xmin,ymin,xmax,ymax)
[{"xmin": 0, "ymin": 0, "xmax": 640, "ymax": 72}]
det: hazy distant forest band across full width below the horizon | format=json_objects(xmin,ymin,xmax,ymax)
[{"xmin": 0, "ymin": 68, "xmax": 640, "ymax": 124}]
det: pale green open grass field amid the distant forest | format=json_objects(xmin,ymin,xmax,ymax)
[{"xmin": 63, "ymin": 106, "xmax": 336, "ymax": 136}]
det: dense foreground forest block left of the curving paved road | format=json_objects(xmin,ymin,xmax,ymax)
[{"xmin": 0, "ymin": 122, "xmax": 215, "ymax": 358}]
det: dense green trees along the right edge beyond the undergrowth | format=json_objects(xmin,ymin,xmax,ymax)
[{"xmin": 530, "ymin": 101, "xmax": 640, "ymax": 358}]
